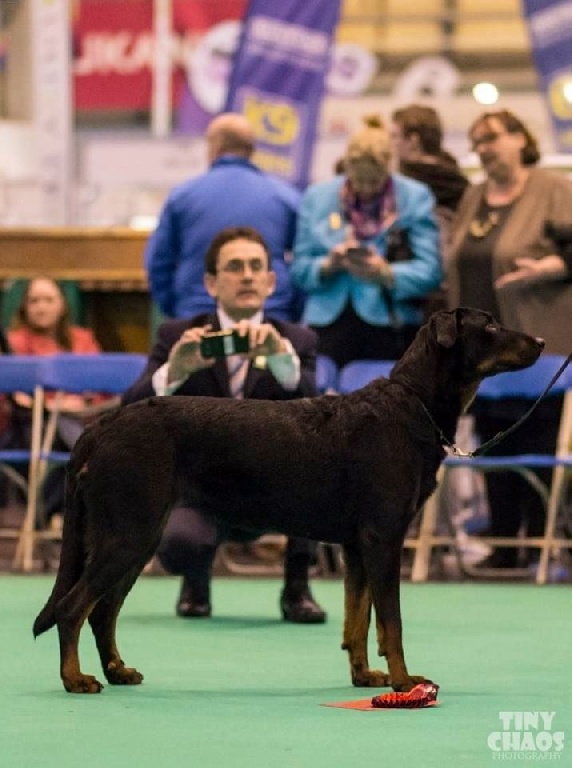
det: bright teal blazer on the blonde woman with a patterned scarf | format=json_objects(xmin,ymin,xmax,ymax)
[{"xmin": 290, "ymin": 174, "xmax": 442, "ymax": 326}]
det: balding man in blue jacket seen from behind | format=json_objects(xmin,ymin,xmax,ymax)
[{"xmin": 145, "ymin": 113, "xmax": 300, "ymax": 320}]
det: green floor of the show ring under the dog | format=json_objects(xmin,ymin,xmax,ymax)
[{"xmin": 0, "ymin": 575, "xmax": 572, "ymax": 768}]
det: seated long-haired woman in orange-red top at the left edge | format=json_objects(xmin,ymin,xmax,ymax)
[{"xmin": 7, "ymin": 277, "xmax": 104, "ymax": 519}]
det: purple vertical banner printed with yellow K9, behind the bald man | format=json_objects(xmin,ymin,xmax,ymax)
[{"xmin": 225, "ymin": 0, "xmax": 340, "ymax": 188}]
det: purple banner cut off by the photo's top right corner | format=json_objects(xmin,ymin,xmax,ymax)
[{"xmin": 522, "ymin": 0, "xmax": 572, "ymax": 152}]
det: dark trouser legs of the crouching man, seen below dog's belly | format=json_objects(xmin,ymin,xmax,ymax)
[{"xmin": 157, "ymin": 506, "xmax": 317, "ymax": 603}]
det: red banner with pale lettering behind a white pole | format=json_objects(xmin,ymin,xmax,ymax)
[{"xmin": 73, "ymin": 0, "xmax": 246, "ymax": 110}]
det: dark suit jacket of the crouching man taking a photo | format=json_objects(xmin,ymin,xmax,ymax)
[{"xmin": 122, "ymin": 314, "xmax": 317, "ymax": 404}]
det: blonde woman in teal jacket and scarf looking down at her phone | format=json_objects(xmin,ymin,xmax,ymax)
[{"xmin": 291, "ymin": 116, "xmax": 442, "ymax": 366}]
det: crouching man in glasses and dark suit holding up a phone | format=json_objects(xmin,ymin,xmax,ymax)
[{"xmin": 123, "ymin": 227, "xmax": 326, "ymax": 624}]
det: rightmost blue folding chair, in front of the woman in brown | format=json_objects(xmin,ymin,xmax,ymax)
[{"xmin": 413, "ymin": 355, "xmax": 572, "ymax": 584}]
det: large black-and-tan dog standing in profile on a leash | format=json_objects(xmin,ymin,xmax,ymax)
[{"xmin": 34, "ymin": 309, "xmax": 544, "ymax": 693}]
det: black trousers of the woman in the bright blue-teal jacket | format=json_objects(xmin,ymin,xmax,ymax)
[{"xmin": 312, "ymin": 304, "xmax": 419, "ymax": 368}]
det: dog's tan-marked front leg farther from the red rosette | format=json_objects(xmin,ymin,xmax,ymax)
[{"xmin": 342, "ymin": 546, "xmax": 389, "ymax": 687}]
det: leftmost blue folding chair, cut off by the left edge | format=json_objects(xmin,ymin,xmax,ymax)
[{"xmin": 0, "ymin": 355, "xmax": 42, "ymax": 567}]
